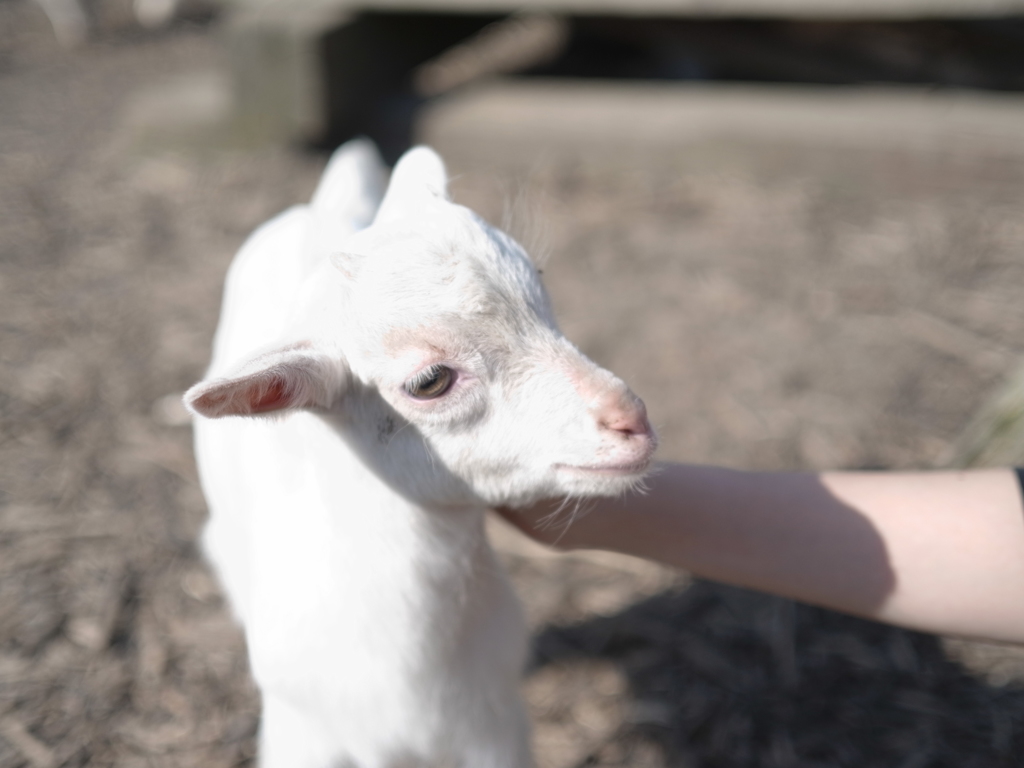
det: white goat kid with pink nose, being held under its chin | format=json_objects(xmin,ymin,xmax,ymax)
[{"xmin": 185, "ymin": 142, "xmax": 654, "ymax": 768}]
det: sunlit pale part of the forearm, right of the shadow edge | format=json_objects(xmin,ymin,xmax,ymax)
[{"xmin": 822, "ymin": 470, "xmax": 1024, "ymax": 642}]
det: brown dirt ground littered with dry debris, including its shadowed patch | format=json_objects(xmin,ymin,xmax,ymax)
[{"xmin": 0, "ymin": 6, "xmax": 1024, "ymax": 768}]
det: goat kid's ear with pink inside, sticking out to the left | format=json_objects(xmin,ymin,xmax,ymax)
[{"xmin": 184, "ymin": 347, "xmax": 347, "ymax": 419}]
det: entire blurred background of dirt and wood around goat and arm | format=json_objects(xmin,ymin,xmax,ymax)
[{"xmin": 0, "ymin": 0, "xmax": 1024, "ymax": 768}]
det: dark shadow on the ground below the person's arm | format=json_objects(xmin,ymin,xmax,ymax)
[{"xmin": 534, "ymin": 582, "xmax": 1024, "ymax": 768}]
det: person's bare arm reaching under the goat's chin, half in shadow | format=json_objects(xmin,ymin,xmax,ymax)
[{"xmin": 500, "ymin": 463, "xmax": 1024, "ymax": 643}]
